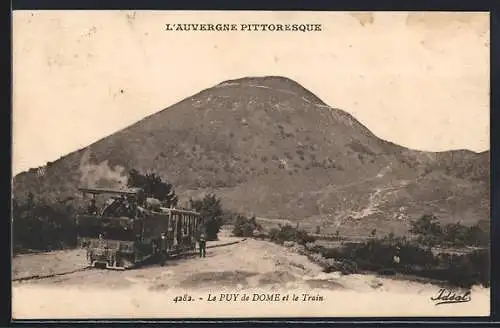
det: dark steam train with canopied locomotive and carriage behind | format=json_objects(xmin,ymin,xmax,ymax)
[{"xmin": 76, "ymin": 188, "xmax": 201, "ymax": 269}]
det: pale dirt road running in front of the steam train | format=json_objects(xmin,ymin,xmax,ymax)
[{"xmin": 14, "ymin": 238, "xmax": 321, "ymax": 290}]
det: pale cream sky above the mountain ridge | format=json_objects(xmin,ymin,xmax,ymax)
[{"xmin": 12, "ymin": 11, "xmax": 490, "ymax": 174}]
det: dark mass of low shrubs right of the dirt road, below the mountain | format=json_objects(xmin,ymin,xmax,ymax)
[{"xmin": 260, "ymin": 215, "xmax": 490, "ymax": 288}]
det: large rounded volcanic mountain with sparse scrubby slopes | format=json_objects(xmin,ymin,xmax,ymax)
[{"xmin": 14, "ymin": 77, "xmax": 490, "ymax": 234}]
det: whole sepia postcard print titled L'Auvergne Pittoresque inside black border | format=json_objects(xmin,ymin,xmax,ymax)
[{"xmin": 11, "ymin": 10, "xmax": 491, "ymax": 320}]
